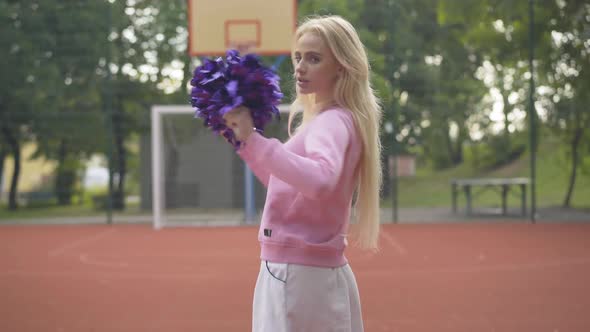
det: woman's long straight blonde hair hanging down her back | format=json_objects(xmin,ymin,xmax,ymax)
[{"xmin": 288, "ymin": 16, "xmax": 382, "ymax": 249}]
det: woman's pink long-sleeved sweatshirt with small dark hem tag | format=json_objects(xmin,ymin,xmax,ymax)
[{"xmin": 238, "ymin": 108, "xmax": 362, "ymax": 267}]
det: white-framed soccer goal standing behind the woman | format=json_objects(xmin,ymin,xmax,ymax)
[{"xmin": 151, "ymin": 105, "xmax": 290, "ymax": 229}]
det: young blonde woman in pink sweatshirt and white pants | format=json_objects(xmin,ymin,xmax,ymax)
[{"xmin": 225, "ymin": 16, "xmax": 381, "ymax": 332}]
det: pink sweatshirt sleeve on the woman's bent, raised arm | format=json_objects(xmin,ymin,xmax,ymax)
[{"xmin": 238, "ymin": 111, "xmax": 354, "ymax": 199}]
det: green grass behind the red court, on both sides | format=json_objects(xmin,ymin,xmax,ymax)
[{"xmin": 0, "ymin": 136, "xmax": 590, "ymax": 223}]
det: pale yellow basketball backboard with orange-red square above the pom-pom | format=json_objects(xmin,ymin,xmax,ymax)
[{"xmin": 188, "ymin": 0, "xmax": 297, "ymax": 56}]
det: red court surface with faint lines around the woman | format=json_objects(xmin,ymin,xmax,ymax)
[{"xmin": 0, "ymin": 222, "xmax": 590, "ymax": 332}]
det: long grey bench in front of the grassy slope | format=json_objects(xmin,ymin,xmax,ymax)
[{"xmin": 451, "ymin": 178, "xmax": 529, "ymax": 217}]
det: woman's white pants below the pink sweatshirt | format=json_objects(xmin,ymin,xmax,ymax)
[{"xmin": 252, "ymin": 261, "xmax": 363, "ymax": 332}]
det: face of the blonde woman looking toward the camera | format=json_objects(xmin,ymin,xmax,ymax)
[{"xmin": 293, "ymin": 33, "xmax": 342, "ymax": 103}]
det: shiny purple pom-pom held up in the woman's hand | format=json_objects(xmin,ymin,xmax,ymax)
[{"xmin": 191, "ymin": 50, "xmax": 283, "ymax": 148}]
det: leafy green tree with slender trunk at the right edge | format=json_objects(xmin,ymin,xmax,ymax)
[{"xmin": 540, "ymin": 1, "xmax": 590, "ymax": 207}]
